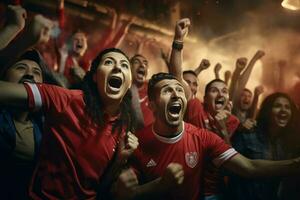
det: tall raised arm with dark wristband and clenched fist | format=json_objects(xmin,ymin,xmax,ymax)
[{"xmin": 169, "ymin": 18, "xmax": 192, "ymax": 100}]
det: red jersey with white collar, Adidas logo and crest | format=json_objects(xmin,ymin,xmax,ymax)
[{"xmin": 132, "ymin": 123, "xmax": 237, "ymax": 200}]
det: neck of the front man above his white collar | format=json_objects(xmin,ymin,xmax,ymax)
[{"xmin": 153, "ymin": 120, "xmax": 183, "ymax": 138}]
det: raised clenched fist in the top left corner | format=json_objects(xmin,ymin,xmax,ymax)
[{"xmin": 7, "ymin": 5, "xmax": 27, "ymax": 30}]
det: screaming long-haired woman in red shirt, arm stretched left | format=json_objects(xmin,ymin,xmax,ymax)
[{"xmin": 0, "ymin": 48, "xmax": 138, "ymax": 199}]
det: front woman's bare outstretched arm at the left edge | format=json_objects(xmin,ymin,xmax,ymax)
[{"xmin": 0, "ymin": 81, "xmax": 28, "ymax": 108}]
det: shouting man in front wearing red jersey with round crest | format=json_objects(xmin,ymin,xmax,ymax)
[{"xmin": 112, "ymin": 73, "xmax": 300, "ymax": 200}]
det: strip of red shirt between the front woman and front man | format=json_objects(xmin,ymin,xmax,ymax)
[{"xmin": 138, "ymin": 82, "xmax": 154, "ymax": 127}]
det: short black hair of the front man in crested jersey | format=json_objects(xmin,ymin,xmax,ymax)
[{"xmin": 148, "ymin": 72, "xmax": 178, "ymax": 101}]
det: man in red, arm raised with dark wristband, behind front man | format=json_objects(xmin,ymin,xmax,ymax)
[{"xmin": 169, "ymin": 19, "xmax": 239, "ymax": 199}]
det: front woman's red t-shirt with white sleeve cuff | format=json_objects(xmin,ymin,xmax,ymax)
[{"xmin": 25, "ymin": 84, "xmax": 123, "ymax": 199}]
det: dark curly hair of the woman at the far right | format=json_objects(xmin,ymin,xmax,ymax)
[{"xmin": 256, "ymin": 92, "xmax": 298, "ymax": 133}]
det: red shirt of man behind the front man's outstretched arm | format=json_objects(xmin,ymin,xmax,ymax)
[{"xmin": 185, "ymin": 98, "xmax": 240, "ymax": 196}]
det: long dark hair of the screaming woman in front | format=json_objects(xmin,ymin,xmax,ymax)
[{"xmin": 82, "ymin": 48, "xmax": 136, "ymax": 133}]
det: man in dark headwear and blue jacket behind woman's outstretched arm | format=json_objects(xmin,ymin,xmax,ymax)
[{"xmin": 0, "ymin": 49, "xmax": 58, "ymax": 199}]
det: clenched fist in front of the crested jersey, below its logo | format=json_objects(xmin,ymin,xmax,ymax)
[{"xmin": 161, "ymin": 163, "xmax": 184, "ymax": 189}]
